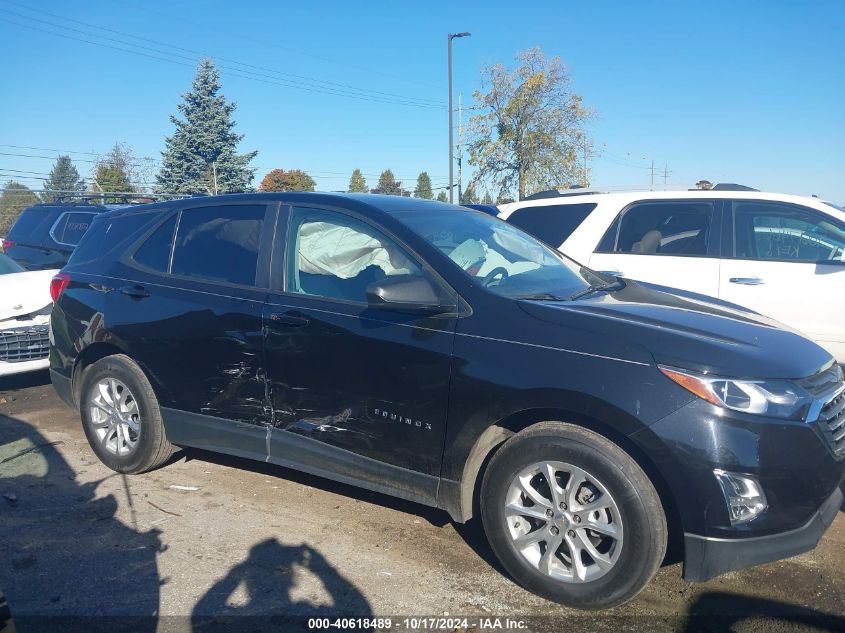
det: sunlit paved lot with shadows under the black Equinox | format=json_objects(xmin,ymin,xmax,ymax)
[{"xmin": 0, "ymin": 374, "xmax": 845, "ymax": 632}]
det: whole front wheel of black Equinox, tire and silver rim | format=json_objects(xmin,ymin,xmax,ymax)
[{"xmin": 481, "ymin": 422, "xmax": 667, "ymax": 609}]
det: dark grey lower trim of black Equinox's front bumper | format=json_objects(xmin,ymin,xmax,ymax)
[{"xmin": 684, "ymin": 488, "xmax": 843, "ymax": 582}]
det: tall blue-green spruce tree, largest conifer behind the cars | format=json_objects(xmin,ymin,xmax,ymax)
[{"xmin": 156, "ymin": 59, "xmax": 258, "ymax": 194}]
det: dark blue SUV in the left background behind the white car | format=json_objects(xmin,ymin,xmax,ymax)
[{"xmin": 3, "ymin": 194, "xmax": 151, "ymax": 270}]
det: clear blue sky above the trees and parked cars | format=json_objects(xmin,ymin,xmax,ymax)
[{"xmin": 0, "ymin": 0, "xmax": 845, "ymax": 204}]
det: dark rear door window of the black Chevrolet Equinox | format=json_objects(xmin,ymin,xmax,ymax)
[{"xmin": 170, "ymin": 204, "xmax": 266, "ymax": 285}]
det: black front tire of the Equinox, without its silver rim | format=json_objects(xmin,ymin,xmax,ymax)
[{"xmin": 480, "ymin": 422, "xmax": 667, "ymax": 609}]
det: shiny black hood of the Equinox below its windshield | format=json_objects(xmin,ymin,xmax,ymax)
[{"xmin": 520, "ymin": 280, "xmax": 833, "ymax": 379}]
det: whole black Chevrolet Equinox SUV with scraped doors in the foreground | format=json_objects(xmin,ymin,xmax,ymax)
[{"xmin": 50, "ymin": 194, "xmax": 845, "ymax": 608}]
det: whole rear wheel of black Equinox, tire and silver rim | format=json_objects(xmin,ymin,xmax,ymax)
[{"xmin": 80, "ymin": 354, "xmax": 173, "ymax": 473}]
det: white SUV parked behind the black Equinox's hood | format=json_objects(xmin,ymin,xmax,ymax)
[{"xmin": 499, "ymin": 187, "xmax": 845, "ymax": 363}]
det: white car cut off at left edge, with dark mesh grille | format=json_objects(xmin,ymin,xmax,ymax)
[{"xmin": 0, "ymin": 254, "xmax": 58, "ymax": 377}]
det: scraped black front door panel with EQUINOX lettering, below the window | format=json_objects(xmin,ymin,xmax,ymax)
[{"xmin": 264, "ymin": 294, "xmax": 455, "ymax": 475}]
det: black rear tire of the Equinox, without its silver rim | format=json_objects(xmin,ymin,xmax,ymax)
[{"xmin": 79, "ymin": 354, "xmax": 174, "ymax": 474}]
